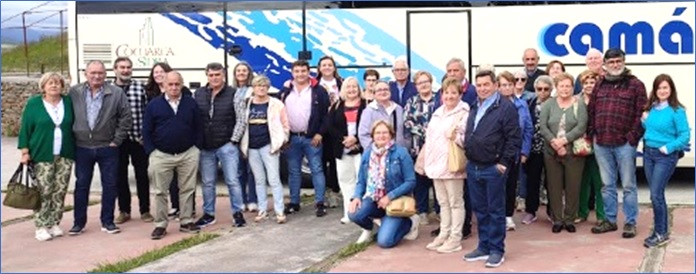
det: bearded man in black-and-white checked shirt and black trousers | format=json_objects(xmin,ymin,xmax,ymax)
[{"xmin": 114, "ymin": 57, "xmax": 154, "ymax": 224}]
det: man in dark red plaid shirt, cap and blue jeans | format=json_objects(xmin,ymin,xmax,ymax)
[{"xmin": 587, "ymin": 48, "xmax": 647, "ymax": 238}]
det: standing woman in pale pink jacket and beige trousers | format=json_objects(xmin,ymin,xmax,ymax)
[{"xmin": 423, "ymin": 78, "xmax": 469, "ymax": 253}]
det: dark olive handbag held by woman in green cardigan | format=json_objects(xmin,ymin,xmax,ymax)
[{"xmin": 2, "ymin": 164, "xmax": 41, "ymax": 210}]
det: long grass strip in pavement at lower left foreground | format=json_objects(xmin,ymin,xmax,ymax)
[{"xmin": 87, "ymin": 233, "xmax": 220, "ymax": 273}]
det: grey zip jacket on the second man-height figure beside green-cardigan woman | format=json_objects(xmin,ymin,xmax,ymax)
[{"xmin": 69, "ymin": 83, "xmax": 132, "ymax": 148}]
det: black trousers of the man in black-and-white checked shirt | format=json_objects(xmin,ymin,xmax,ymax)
[{"xmin": 116, "ymin": 139, "xmax": 150, "ymax": 214}]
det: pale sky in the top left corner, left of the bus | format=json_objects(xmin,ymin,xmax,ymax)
[{"xmin": 0, "ymin": 1, "xmax": 68, "ymax": 28}]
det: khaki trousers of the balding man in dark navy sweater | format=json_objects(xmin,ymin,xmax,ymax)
[{"xmin": 147, "ymin": 146, "xmax": 200, "ymax": 228}]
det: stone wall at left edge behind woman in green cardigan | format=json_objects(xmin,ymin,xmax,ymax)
[{"xmin": 2, "ymin": 77, "xmax": 40, "ymax": 137}]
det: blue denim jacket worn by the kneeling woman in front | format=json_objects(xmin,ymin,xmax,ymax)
[{"xmin": 353, "ymin": 144, "xmax": 416, "ymax": 200}]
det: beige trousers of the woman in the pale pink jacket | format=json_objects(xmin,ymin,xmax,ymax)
[{"xmin": 433, "ymin": 179, "xmax": 464, "ymax": 241}]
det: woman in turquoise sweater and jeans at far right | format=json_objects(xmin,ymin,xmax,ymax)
[{"xmin": 642, "ymin": 74, "xmax": 690, "ymax": 248}]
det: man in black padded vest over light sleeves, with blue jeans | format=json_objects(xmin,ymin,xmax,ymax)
[{"xmin": 193, "ymin": 63, "xmax": 246, "ymax": 227}]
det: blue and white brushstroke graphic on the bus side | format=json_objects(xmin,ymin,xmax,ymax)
[{"xmin": 162, "ymin": 10, "xmax": 444, "ymax": 88}]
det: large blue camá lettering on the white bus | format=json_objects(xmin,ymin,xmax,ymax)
[{"xmin": 539, "ymin": 7, "xmax": 694, "ymax": 57}]
